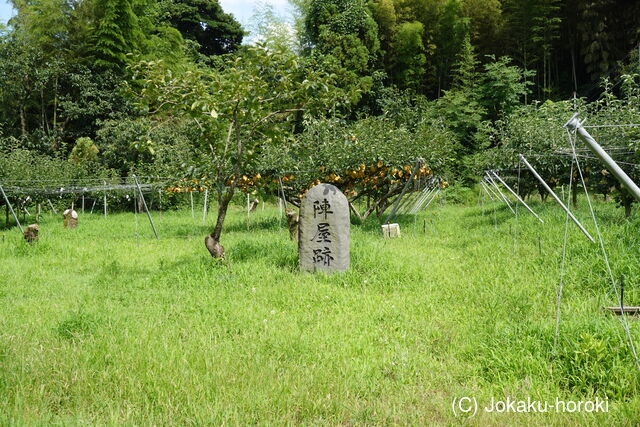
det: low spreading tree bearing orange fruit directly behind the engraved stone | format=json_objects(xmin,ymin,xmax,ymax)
[{"xmin": 250, "ymin": 117, "xmax": 457, "ymax": 221}]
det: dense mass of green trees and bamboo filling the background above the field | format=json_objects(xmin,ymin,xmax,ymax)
[{"xmin": 0, "ymin": 0, "xmax": 640, "ymax": 224}]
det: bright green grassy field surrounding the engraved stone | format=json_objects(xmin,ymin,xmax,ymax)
[{"xmin": 0, "ymin": 196, "xmax": 640, "ymax": 425}]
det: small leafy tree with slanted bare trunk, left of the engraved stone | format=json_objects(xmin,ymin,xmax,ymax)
[{"xmin": 134, "ymin": 44, "xmax": 358, "ymax": 257}]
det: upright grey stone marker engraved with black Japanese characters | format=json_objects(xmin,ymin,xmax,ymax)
[{"xmin": 298, "ymin": 184, "xmax": 351, "ymax": 272}]
